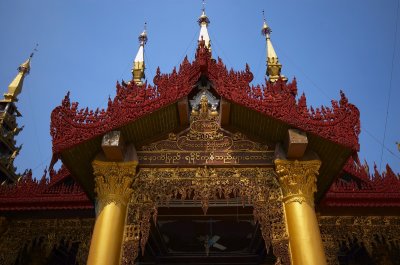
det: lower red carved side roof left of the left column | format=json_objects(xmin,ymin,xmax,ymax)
[{"xmin": 0, "ymin": 166, "xmax": 94, "ymax": 211}]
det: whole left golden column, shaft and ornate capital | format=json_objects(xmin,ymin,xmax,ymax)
[{"xmin": 87, "ymin": 160, "xmax": 138, "ymax": 265}]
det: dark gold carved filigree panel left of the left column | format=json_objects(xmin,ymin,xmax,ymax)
[{"xmin": 0, "ymin": 219, "xmax": 94, "ymax": 265}]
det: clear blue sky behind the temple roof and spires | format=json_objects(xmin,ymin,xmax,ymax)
[{"xmin": 0, "ymin": 0, "xmax": 400, "ymax": 177}]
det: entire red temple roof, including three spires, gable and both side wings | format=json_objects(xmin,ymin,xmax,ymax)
[{"xmin": 0, "ymin": 10, "xmax": 400, "ymax": 211}]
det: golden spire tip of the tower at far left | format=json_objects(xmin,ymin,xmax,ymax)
[{"xmin": 2, "ymin": 50, "xmax": 37, "ymax": 102}]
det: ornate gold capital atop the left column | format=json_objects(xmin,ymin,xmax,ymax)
[{"xmin": 92, "ymin": 160, "xmax": 138, "ymax": 212}]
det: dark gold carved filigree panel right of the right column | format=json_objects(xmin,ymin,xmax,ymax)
[{"xmin": 318, "ymin": 216, "xmax": 400, "ymax": 265}]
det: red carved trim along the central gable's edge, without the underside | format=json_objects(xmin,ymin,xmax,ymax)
[{"xmin": 50, "ymin": 41, "xmax": 360, "ymax": 156}]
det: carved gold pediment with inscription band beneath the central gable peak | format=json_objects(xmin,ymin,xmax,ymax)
[{"xmin": 137, "ymin": 95, "xmax": 274, "ymax": 167}]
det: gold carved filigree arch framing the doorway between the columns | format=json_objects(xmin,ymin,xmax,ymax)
[{"xmin": 123, "ymin": 167, "xmax": 290, "ymax": 264}]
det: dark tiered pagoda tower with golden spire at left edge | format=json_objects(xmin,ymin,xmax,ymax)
[{"xmin": 0, "ymin": 53, "xmax": 33, "ymax": 184}]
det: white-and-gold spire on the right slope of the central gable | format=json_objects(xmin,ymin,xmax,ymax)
[{"xmin": 261, "ymin": 10, "xmax": 287, "ymax": 82}]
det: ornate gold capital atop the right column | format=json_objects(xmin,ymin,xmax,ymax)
[{"xmin": 274, "ymin": 159, "xmax": 321, "ymax": 207}]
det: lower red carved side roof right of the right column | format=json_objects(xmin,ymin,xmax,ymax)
[{"xmin": 321, "ymin": 157, "xmax": 400, "ymax": 207}]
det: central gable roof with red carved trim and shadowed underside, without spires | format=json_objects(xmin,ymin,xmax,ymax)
[{"xmin": 50, "ymin": 40, "xmax": 360, "ymax": 198}]
